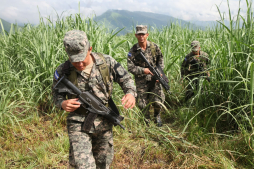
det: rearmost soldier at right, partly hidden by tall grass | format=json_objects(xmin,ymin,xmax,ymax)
[{"xmin": 181, "ymin": 41, "xmax": 210, "ymax": 101}]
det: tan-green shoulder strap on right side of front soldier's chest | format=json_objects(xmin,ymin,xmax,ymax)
[{"xmin": 96, "ymin": 53, "xmax": 112, "ymax": 96}]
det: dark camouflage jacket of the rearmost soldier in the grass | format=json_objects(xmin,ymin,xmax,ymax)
[{"xmin": 181, "ymin": 51, "xmax": 210, "ymax": 78}]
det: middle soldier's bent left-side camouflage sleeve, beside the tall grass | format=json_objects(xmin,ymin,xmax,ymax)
[{"xmin": 127, "ymin": 47, "xmax": 145, "ymax": 76}]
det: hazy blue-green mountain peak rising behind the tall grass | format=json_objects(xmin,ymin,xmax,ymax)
[{"xmin": 94, "ymin": 10, "xmax": 203, "ymax": 34}]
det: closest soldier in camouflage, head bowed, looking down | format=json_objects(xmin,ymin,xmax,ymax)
[{"xmin": 52, "ymin": 30, "xmax": 137, "ymax": 169}]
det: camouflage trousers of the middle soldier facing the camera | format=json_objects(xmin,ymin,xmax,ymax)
[{"xmin": 136, "ymin": 82, "xmax": 165, "ymax": 120}]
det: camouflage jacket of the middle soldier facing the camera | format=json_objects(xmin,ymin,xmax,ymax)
[{"xmin": 127, "ymin": 41, "xmax": 164, "ymax": 83}]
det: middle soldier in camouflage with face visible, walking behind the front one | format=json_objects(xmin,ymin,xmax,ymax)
[{"xmin": 127, "ymin": 25, "xmax": 165, "ymax": 127}]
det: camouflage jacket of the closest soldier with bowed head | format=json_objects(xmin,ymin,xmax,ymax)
[{"xmin": 52, "ymin": 53, "xmax": 137, "ymax": 133}]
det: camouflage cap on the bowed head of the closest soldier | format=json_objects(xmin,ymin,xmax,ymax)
[{"xmin": 63, "ymin": 30, "xmax": 90, "ymax": 62}]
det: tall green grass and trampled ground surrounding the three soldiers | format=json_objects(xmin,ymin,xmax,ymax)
[{"xmin": 0, "ymin": 1, "xmax": 254, "ymax": 168}]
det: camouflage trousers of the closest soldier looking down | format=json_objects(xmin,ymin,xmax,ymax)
[{"xmin": 67, "ymin": 120, "xmax": 114, "ymax": 169}]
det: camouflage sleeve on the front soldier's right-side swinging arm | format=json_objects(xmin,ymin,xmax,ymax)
[{"xmin": 110, "ymin": 57, "xmax": 137, "ymax": 97}]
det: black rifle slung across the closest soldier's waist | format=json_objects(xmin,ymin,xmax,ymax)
[{"xmin": 54, "ymin": 75, "xmax": 125, "ymax": 132}]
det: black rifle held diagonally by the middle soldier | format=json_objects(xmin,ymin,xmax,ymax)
[{"xmin": 139, "ymin": 51, "xmax": 171, "ymax": 94}]
